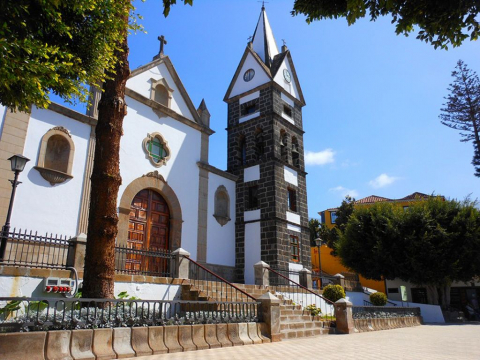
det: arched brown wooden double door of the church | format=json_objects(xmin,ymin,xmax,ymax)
[{"xmin": 126, "ymin": 189, "xmax": 170, "ymax": 276}]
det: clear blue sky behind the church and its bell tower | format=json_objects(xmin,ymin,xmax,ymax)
[{"xmin": 63, "ymin": 0, "xmax": 480, "ymax": 218}]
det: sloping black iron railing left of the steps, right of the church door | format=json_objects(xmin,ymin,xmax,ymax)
[{"xmin": 185, "ymin": 257, "xmax": 257, "ymax": 303}]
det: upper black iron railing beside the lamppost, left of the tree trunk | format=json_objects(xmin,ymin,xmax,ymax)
[{"xmin": 0, "ymin": 229, "xmax": 70, "ymax": 269}]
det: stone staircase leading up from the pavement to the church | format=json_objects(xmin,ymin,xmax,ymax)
[{"xmin": 182, "ymin": 281, "xmax": 335, "ymax": 340}]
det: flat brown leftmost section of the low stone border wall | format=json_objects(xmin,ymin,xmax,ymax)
[{"xmin": 0, "ymin": 331, "xmax": 47, "ymax": 360}]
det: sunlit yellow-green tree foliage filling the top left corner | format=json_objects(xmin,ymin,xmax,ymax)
[{"xmin": 0, "ymin": 0, "xmax": 137, "ymax": 112}]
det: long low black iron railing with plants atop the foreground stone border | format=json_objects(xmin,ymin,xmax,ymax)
[{"xmin": 0, "ymin": 297, "xmax": 258, "ymax": 333}]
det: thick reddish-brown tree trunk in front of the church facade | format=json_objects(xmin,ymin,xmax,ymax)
[{"xmin": 83, "ymin": 14, "xmax": 130, "ymax": 298}]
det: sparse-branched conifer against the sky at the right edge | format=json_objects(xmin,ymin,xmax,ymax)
[{"xmin": 440, "ymin": 60, "xmax": 480, "ymax": 177}]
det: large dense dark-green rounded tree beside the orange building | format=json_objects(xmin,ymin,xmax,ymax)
[{"xmin": 337, "ymin": 197, "xmax": 480, "ymax": 308}]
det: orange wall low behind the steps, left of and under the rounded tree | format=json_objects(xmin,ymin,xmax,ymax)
[{"xmin": 311, "ymin": 245, "xmax": 386, "ymax": 293}]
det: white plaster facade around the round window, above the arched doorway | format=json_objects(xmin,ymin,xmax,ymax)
[{"xmin": 122, "ymin": 98, "xmax": 201, "ymax": 260}]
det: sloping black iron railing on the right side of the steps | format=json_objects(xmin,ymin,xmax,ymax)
[{"xmin": 267, "ymin": 268, "xmax": 335, "ymax": 320}]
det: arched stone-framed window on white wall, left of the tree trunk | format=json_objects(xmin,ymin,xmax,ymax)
[{"xmin": 35, "ymin": 126, "xmax": 75, "ymax": 185}]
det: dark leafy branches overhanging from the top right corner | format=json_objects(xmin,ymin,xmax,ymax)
[{"xmin": 292, "ymin": 0, "xmax": 480, "ymax": 49}]
